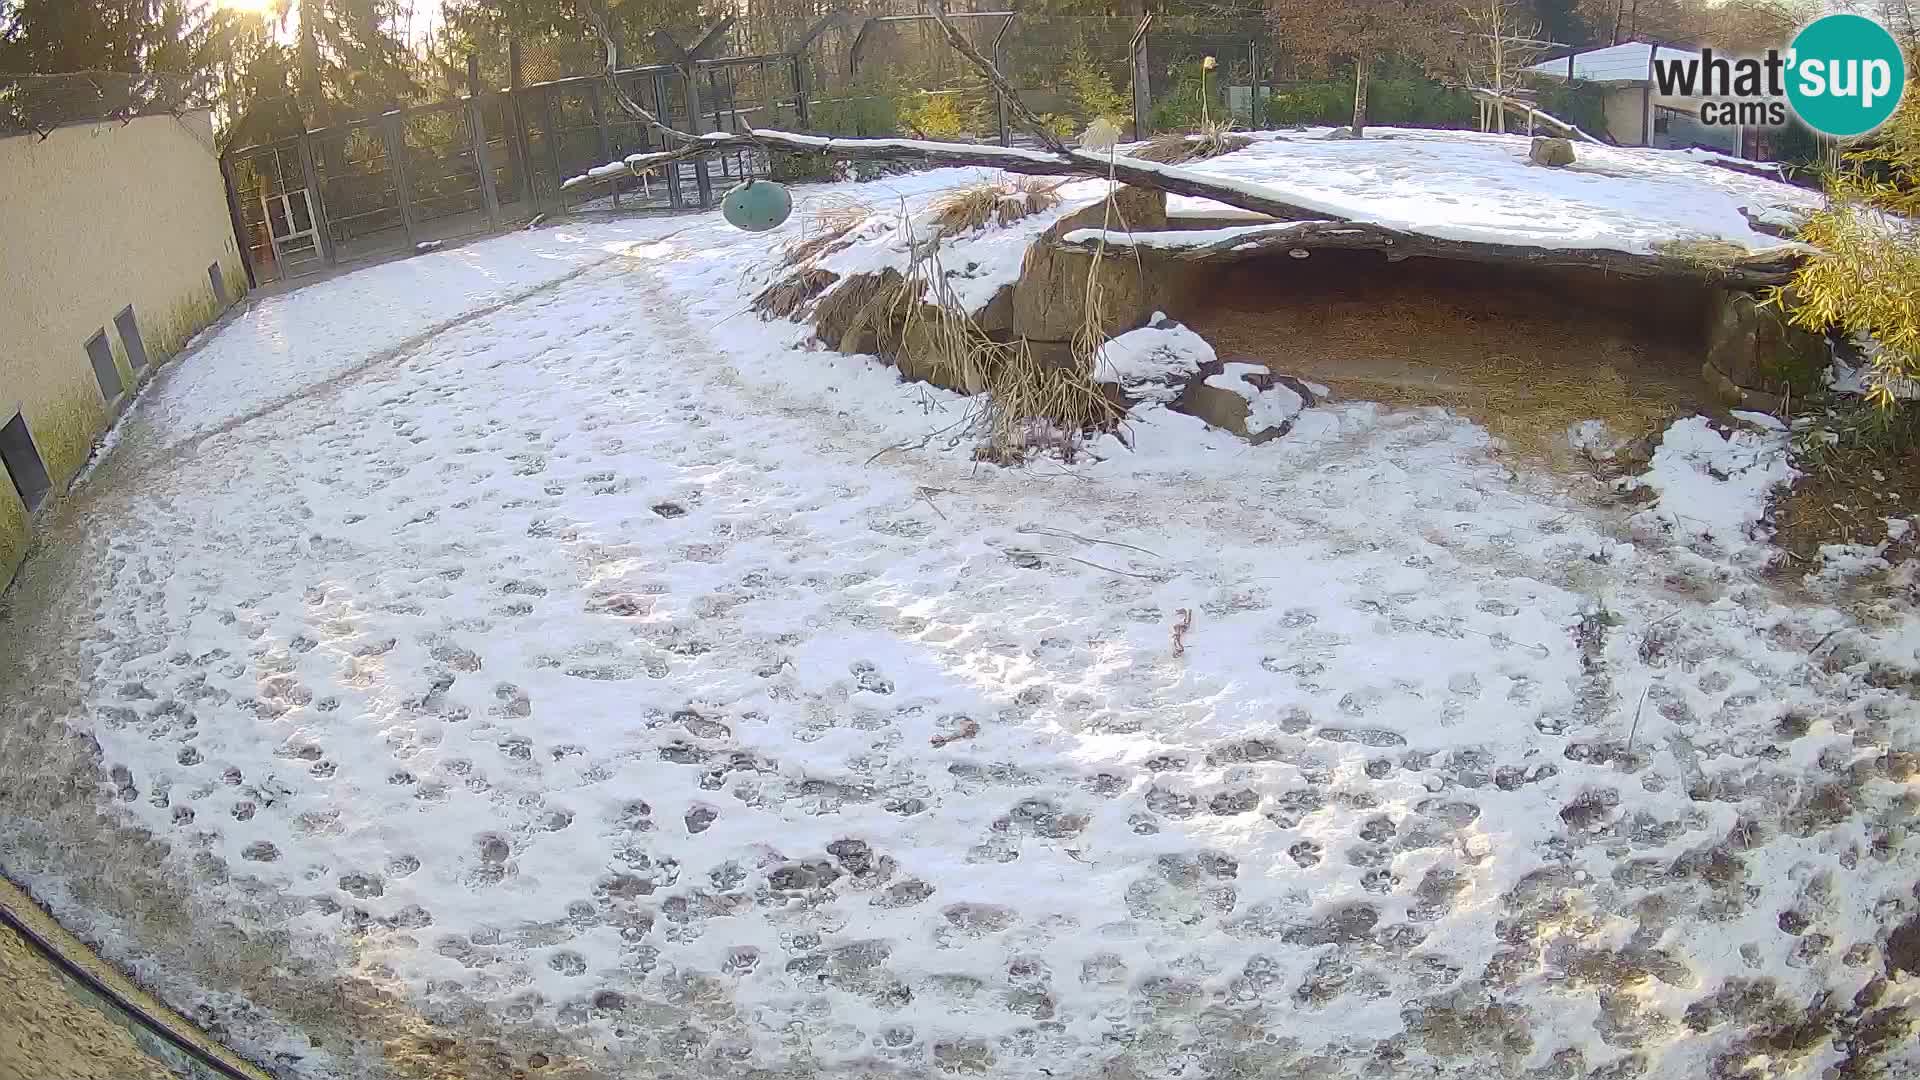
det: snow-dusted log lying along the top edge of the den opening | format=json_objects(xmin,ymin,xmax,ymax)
[{"xmin": 1058, "ymin": 221, "xmax": 1809, "ymax": 288}]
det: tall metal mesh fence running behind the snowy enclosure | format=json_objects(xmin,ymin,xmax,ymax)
[{"xmin": 217, "ymin": 10, "xmax": 1297, "ymax": 286}]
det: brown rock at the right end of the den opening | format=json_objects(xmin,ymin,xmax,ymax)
[{"xmin": 1701, "ymin": 290, "xmax": 1832, "ymax": 411}]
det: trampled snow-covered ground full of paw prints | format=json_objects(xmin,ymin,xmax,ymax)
[{"xmin": 0, "ymin": 148, "xmax": 1920, "ymax": 1078}]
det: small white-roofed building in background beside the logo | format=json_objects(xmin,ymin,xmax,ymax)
[{"xmin": 1526, "ymin": 40, "xmax": 1757, "ymax": 158}]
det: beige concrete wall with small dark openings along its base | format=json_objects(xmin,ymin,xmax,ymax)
[{"xmin": 0, "ymin": 111, "xmax": 246, "ymax": 586}]
